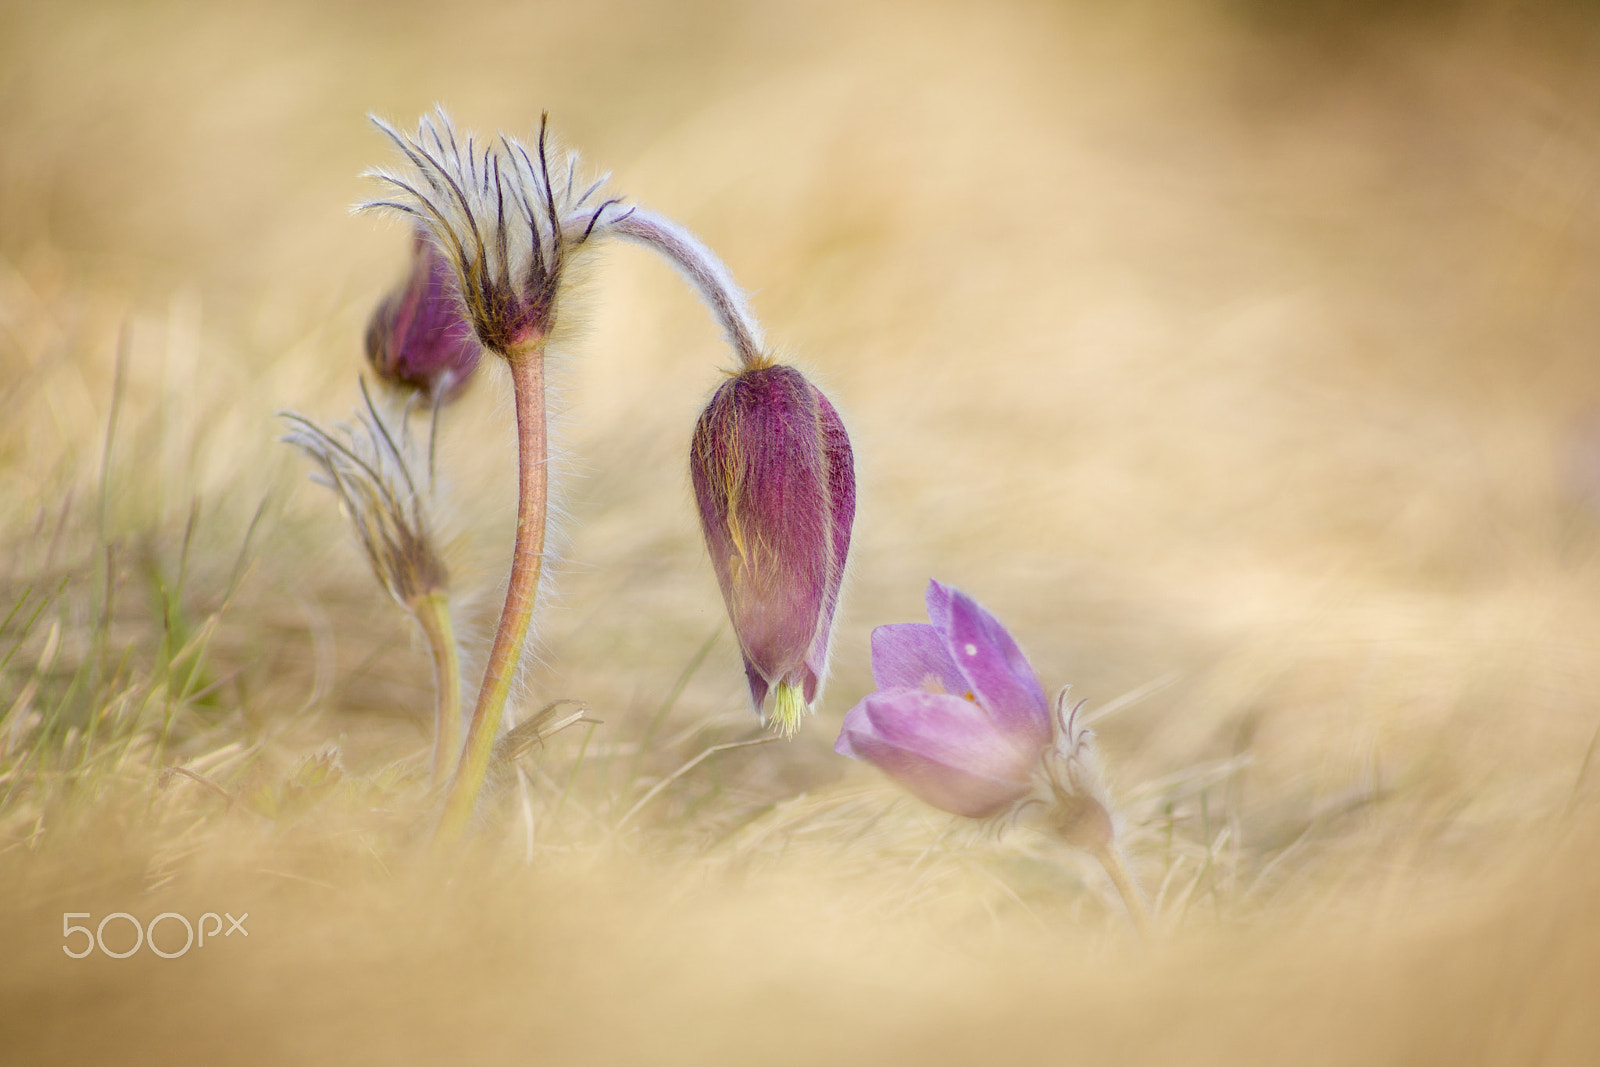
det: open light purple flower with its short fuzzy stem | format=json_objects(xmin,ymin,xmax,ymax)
[{"xmin": 834, "ymin": 581, "xmax": 1149, "ymax": 933}]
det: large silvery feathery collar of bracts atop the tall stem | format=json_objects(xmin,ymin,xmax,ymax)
[{"xmin": 362, "ymin": 110, "xmax": 624, "ymax": 358}]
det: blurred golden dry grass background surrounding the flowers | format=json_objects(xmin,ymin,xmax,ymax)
[{"xmin": 0, "ymin": 0, "xmax": 1600, "ymax": 1064}]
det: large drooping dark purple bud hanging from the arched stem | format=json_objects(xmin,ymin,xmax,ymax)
[{"xmin": 690, "ymin": 363, "xmax": 856, "ymax": 736}]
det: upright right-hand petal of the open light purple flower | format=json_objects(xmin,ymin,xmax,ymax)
[{"xmin": 944, "ymin": 589, "xmax": 1051, "ymax": 749}]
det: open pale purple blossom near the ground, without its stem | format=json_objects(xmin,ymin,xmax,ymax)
[{"xmin": 834, "ymin": 581, "xmax": 1051, "ymax": 819}]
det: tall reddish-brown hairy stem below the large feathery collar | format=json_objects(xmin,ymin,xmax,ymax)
[{"xmin": 437, "ymin": 350, "xmax": 550, "ymax": 843}]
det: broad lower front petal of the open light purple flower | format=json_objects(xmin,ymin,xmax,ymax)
[{"xmin": 834, "ymin": 689, "xmax": 1030, "ymax": 819}]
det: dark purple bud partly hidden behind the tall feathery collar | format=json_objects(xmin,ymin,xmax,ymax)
[{"xmin": 366, "ymin": 227, "xmax": 483, "ymax": 403}]
